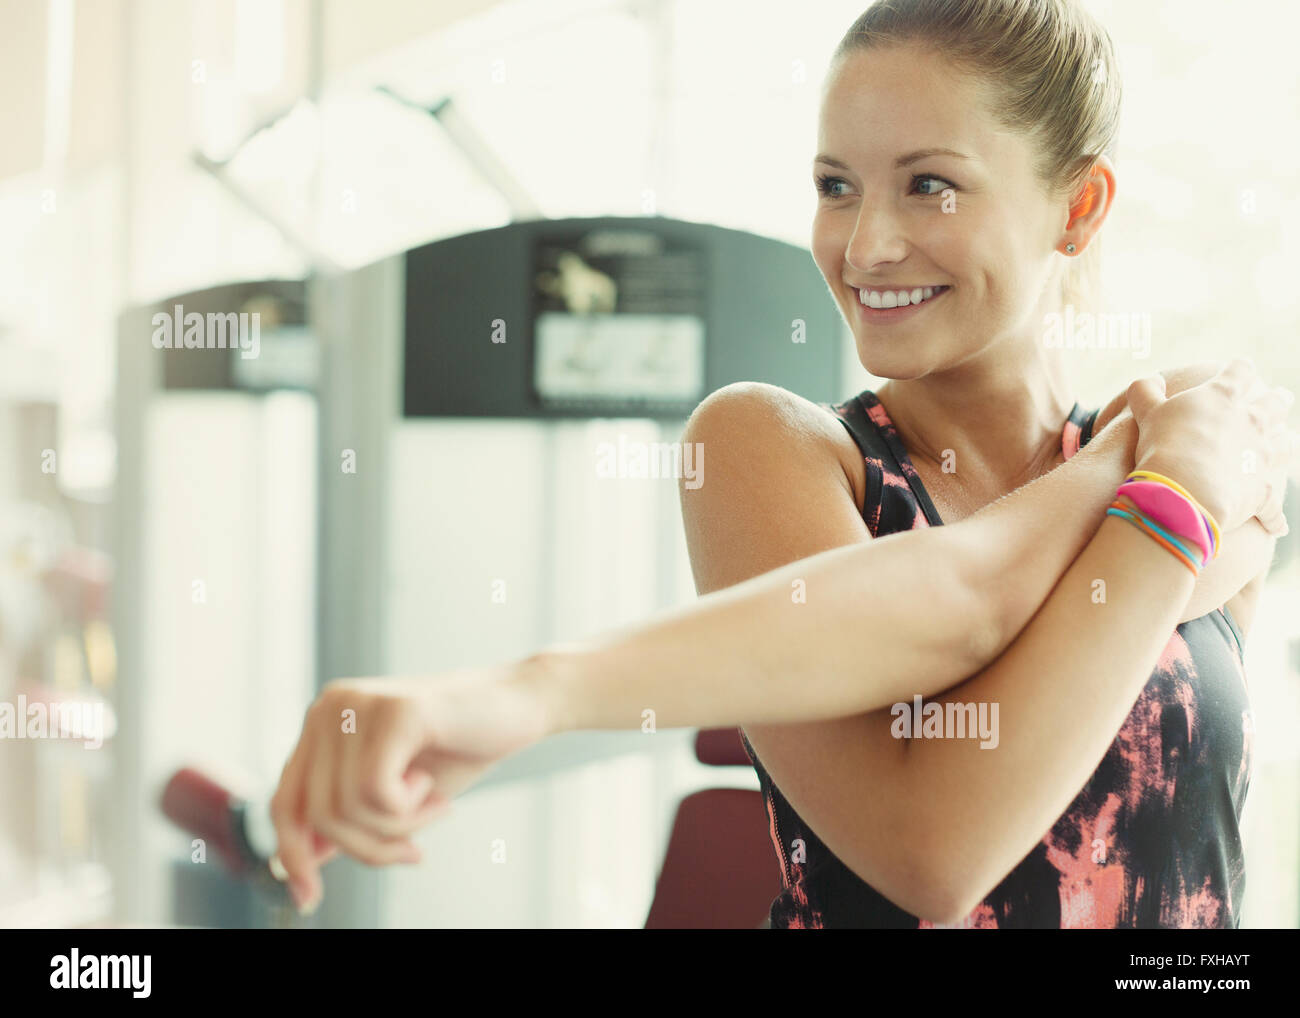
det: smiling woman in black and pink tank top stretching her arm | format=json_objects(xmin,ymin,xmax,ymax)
[{"xmin": 273, "ymin": 0, "xmax": 1294, "ymax": 927}]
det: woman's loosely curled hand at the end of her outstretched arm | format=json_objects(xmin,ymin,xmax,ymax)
[{"xmin": 270, "ymin": 663, "xmax": 551, "ymax": 911}]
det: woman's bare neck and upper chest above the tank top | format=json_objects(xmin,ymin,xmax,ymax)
[{"xmin": 876, "ymin": 345, "xmax": 1074, "ymax": 497}]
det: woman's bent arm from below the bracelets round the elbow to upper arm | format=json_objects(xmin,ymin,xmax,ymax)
[{"xmin": 746, "ymin": 516, "xmax": 1193, "ymax": 922}]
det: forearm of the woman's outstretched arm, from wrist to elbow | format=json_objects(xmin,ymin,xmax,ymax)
[{"xmin": 517, "ymin": 527, "xmax": 992, "ymax": 732}]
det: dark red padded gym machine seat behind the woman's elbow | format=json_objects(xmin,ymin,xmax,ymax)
[{"xmin": 645, "ymin": 728, "xmax": 781, "ymax": 930}]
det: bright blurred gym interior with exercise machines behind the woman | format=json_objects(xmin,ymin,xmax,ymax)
[{"xmin": 0, "ymin": 0, "xmax": 1300, "ymax": 927}]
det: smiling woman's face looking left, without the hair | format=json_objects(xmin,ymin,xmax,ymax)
[{"xmin": 813, "ymin": 47, "xmax": 1069, "ymax": 378}]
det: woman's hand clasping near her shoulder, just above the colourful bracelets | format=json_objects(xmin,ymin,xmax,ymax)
[{"xmin": 1127, "ymin": 359, "xmax": 1300, "ymax": 533}]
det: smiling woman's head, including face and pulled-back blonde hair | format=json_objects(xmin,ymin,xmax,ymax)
[{"xmin": 813, "ymin": 43, "xmax": 1119, "ymax": 377}]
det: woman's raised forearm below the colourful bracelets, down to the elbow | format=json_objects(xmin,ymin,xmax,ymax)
[{"xmin": 900, "ymin": 516, "xmax": 1193, "ymax": 915}]
